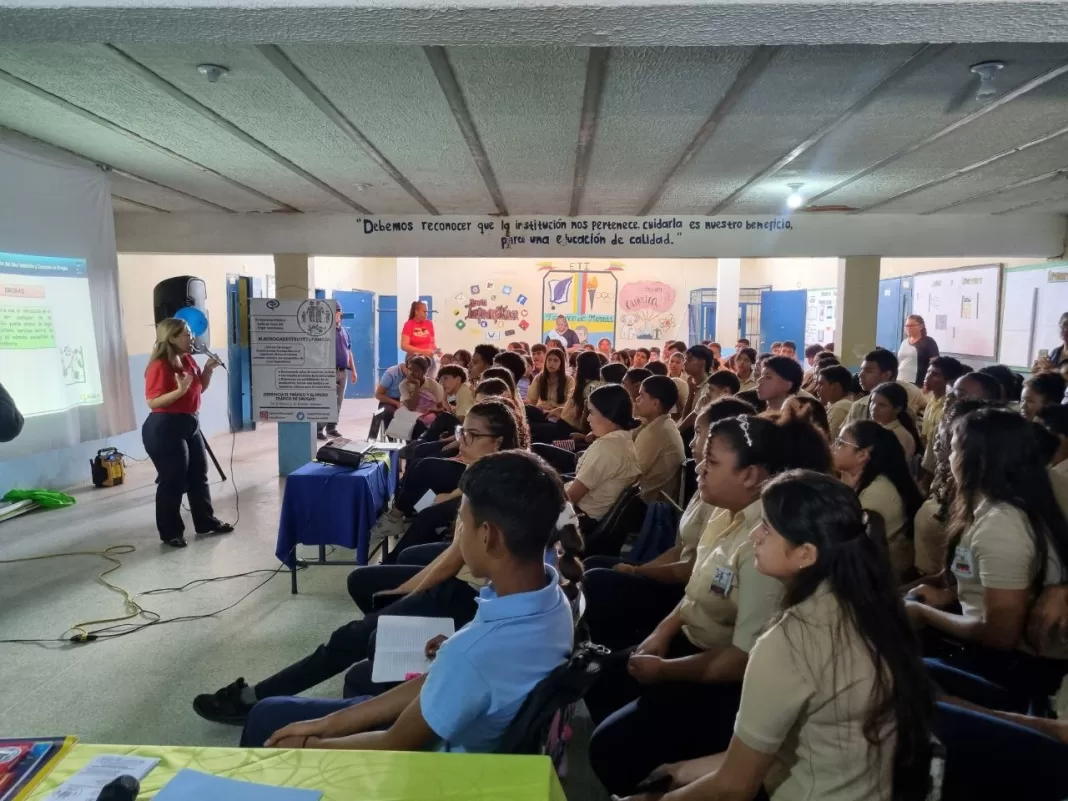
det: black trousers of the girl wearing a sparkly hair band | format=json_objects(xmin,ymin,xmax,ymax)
[{"xmin": 585, "ymin": 634, "xmax": 741, "ymax": 796}]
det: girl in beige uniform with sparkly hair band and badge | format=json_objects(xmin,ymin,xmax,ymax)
[{"xmin": 585, "ymin": 417, "xmax": 831, "ymax": 792}]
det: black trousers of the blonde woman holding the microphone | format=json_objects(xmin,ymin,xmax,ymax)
[{"xmin": 141, "ymin": 412, "xmax": 219, "ymax": 541}]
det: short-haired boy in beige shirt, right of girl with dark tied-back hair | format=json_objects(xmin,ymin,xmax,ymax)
[{"xmin": 634, "ymin": 376, "xmax": 686, "ymax": 503}]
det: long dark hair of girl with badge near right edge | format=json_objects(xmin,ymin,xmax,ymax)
[{"xmin": 946, "ymin": 409, "xmax": 1068, "ymax": 597}]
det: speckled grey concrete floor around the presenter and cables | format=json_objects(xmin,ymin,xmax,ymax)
[{"xmin": 0, "ymin": 401, "xmax": 608, "ymax": 801}]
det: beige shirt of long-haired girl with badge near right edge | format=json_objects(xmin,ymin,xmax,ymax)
[{"xmin": 951, "ymin": 500, "xmax": 1061, "ymax": 651}]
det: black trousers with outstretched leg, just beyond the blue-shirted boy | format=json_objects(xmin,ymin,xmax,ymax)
[{"xmin": 255, "ymin": 565, "xmax": 476, "ymax": 700}]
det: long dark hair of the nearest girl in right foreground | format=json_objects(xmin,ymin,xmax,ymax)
[{"xmin": 761, "ymin": 469, "xmax": 931, "ymax": 801}]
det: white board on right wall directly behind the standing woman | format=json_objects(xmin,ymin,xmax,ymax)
[{"xmin": 912, "ymin": 264, "xmax": 1004, "ymax": 361}]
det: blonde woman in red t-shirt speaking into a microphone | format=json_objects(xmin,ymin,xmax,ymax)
[{"xmin": 141, "ymin": 317, "xmax": 234, "ymax": 548}]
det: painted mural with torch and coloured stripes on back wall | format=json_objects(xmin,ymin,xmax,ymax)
[{"xmin": 540, "ymin": 270, "xmax": 618, "ymax": 351}]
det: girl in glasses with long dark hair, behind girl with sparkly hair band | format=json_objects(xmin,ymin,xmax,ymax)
[{"xmin": 834, "ymin": 420, "xmax": 924, "ymax": 584}]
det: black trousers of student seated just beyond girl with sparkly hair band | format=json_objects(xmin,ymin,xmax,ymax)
[{"xmin": 582, "ymin": 568, "xmax": 686, "ymax": 650}]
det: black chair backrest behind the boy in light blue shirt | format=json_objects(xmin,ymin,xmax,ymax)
[{"xmin": 497, "ymin": 642, "xmax": 611, "ymax": 754}]
